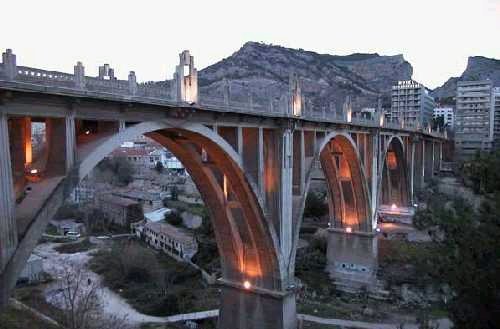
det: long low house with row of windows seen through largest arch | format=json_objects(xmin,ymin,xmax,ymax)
[{"xmin": 142, "ymin": 222, "xmax": 198, "ymax": 260}]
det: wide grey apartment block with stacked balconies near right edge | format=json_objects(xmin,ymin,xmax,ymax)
[{"xmin": 455, "ymin": 80, "xmax": 495, "ymax": 160}]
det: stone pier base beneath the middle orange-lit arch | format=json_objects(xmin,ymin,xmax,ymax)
[{"xmin": 326, "ymin": 228, "xmax": 378, "ymax": 292}]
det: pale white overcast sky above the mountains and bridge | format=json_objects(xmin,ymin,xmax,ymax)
[{"xmin": 0, "ymin": 0, "xmax": 500, "ymax": 88}]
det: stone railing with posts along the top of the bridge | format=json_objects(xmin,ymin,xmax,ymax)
[{"xmin": 0, "ymin": 50, "xmax": 443, "ymax": 137}]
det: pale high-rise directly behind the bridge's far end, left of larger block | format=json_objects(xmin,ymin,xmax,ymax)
[{"xmin": 388, "ymin": 80, "xmax": 436, "ymax": 127}]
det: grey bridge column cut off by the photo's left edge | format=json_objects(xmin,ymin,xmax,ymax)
[{"xmin": 0, "ymin": 110, "xmax": 17, "ymax": 307}]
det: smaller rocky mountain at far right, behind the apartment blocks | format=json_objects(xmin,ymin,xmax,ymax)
[{"xmin": 431, "ymin": 56, "xmax": 500, "ymax": 99}]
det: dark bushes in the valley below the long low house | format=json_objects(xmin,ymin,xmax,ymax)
[{"xmin": 91, "ymin": 240, "xmax": 218, "ymax": 316}]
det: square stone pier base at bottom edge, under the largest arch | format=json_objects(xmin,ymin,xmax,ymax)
[{"xmin": 217, "ymin": 286, "xmax": 297, "ymax": 329}]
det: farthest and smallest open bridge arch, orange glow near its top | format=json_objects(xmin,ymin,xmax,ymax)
[{"xmin": 377, "ymin": 135, "xmax": 410, "ymax": 207}]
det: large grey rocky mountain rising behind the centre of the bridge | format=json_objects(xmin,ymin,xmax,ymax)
[{"xmin": 193, "ymin": 42, "xmax": 413, "ymax": 110}]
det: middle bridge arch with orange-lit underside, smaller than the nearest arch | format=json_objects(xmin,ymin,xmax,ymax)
[{"xmin": 318, "ymin": 132, "xmax": 371, "ymax": 232}]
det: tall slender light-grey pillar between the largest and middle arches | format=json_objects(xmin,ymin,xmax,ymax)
[{"xmin": 280, "ymin": 128, "xmax": 293, "ymax": 276}]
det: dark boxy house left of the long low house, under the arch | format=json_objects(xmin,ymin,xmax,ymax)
[{"xmin": 99, "ymin": 194, "xmax": 144, "ymax": 226}]
